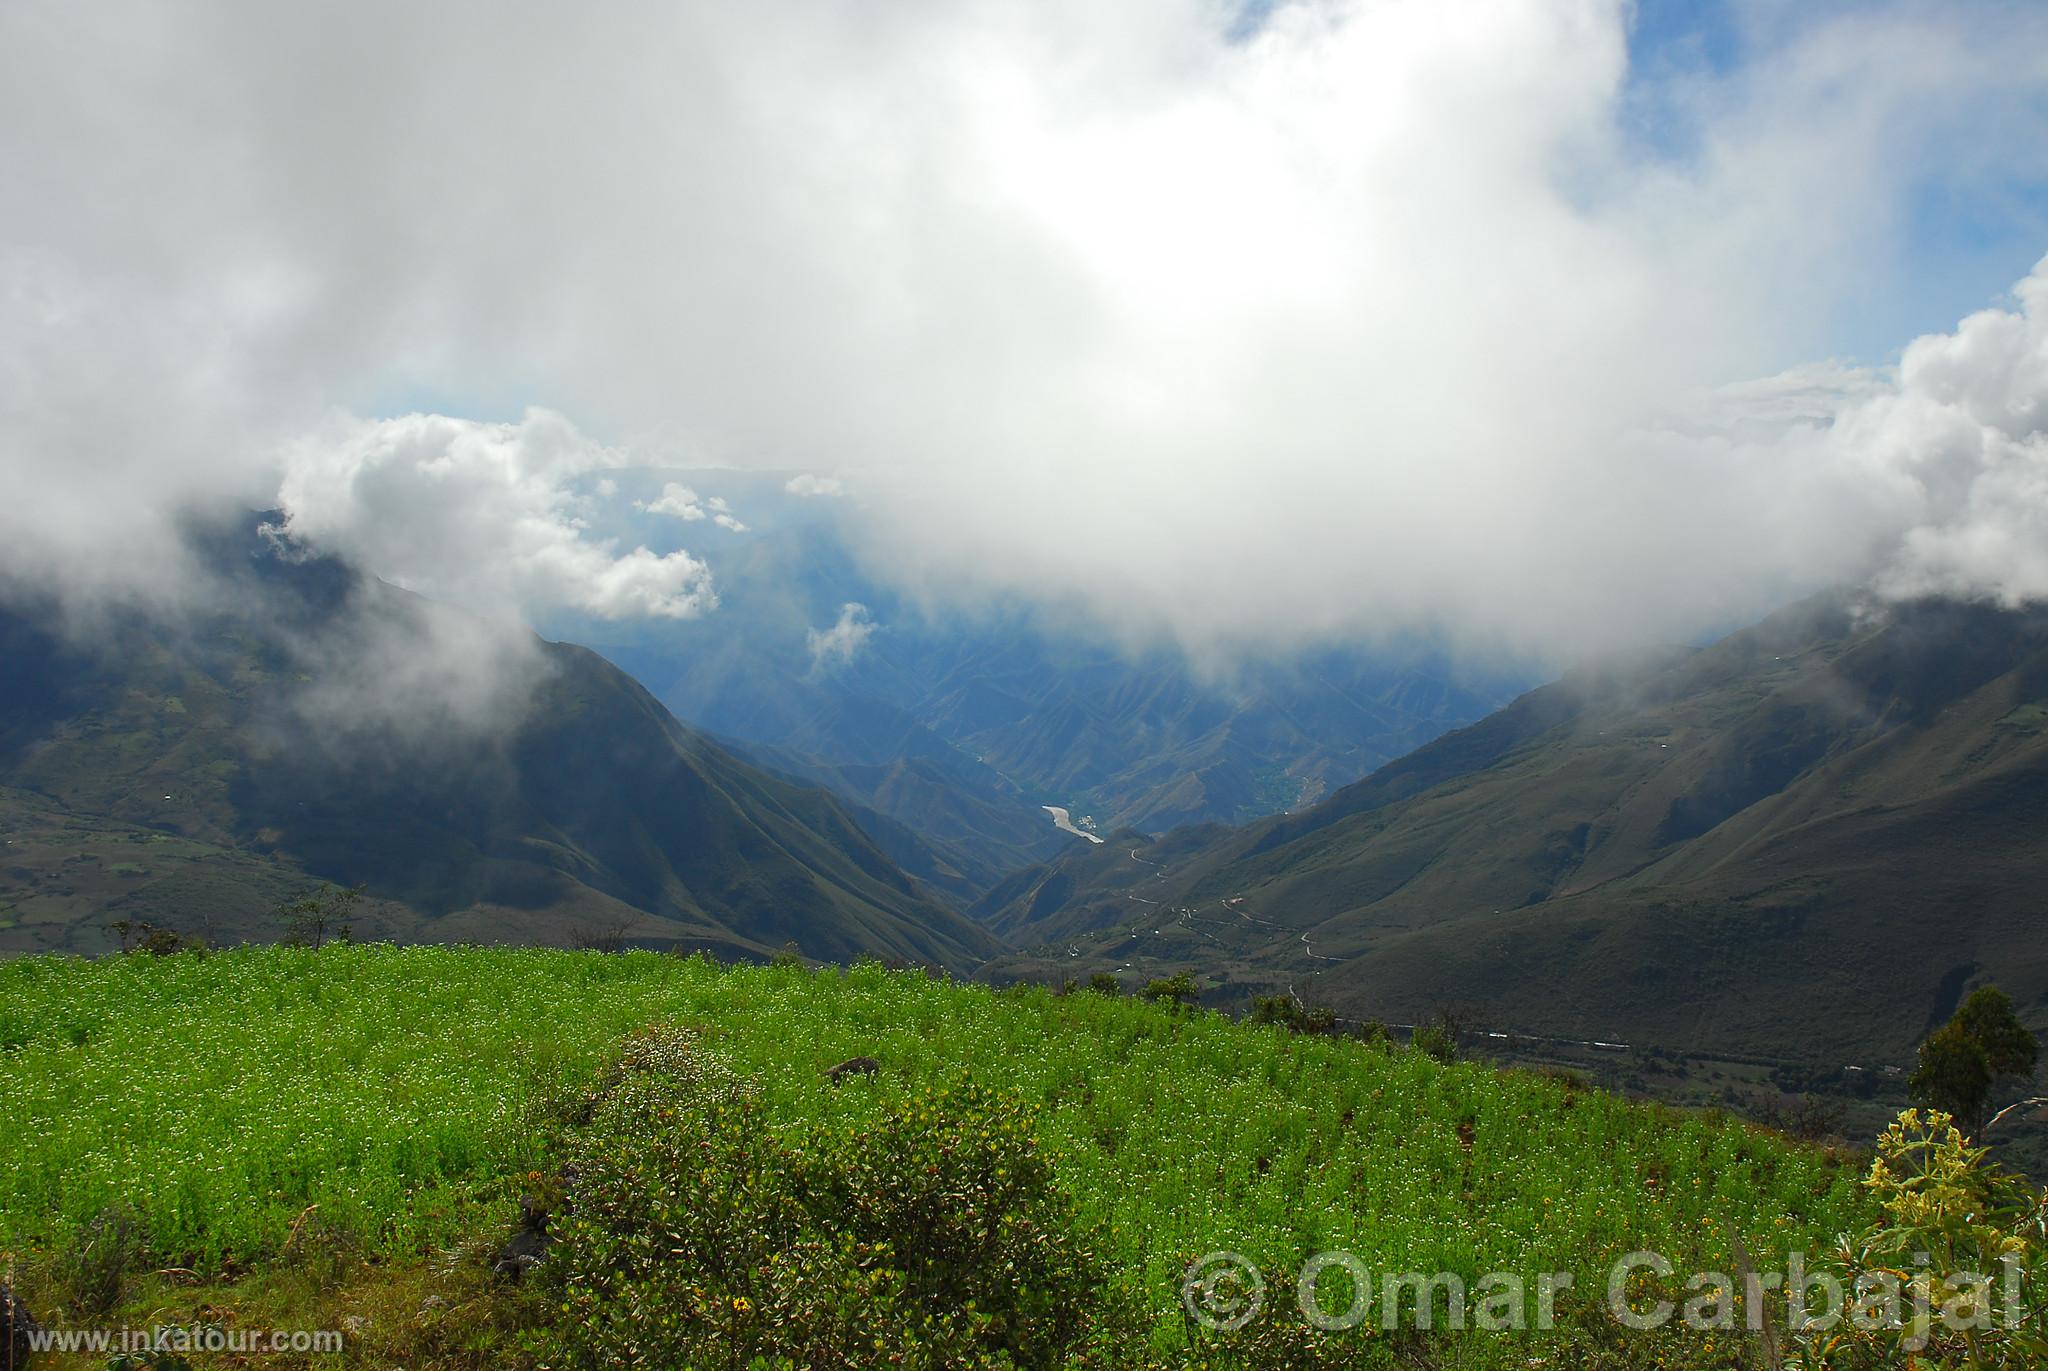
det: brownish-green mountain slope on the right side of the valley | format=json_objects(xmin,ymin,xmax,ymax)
[{"xmin": 981, "ymin": 594, "xmax": 2048, "ymax": 1062}]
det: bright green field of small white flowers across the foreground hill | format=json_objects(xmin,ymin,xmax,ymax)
[{"xmin": 0, "ymin": 947, "xmax": 1868, "ymax": 1365}]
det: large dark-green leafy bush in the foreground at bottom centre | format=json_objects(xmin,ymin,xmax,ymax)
[{"xmin": 541, "ymin": 1029, "xmax": 1102, "ymax": 1367}]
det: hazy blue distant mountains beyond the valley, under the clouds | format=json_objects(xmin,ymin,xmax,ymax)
[{"xmin": 559, "ymin": 469, "xmax": 1528, "ymax": 896}]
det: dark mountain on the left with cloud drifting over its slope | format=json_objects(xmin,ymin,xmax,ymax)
[{"xmin": 0, "ymin": 518, "xmax": 997, "ymax": 967}]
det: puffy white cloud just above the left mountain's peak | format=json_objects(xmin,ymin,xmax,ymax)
[{"xmin": 279, "ymin": 410, "xmax": 717, "ymax": 619}]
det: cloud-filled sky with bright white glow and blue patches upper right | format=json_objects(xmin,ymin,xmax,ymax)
[{"xmin": 0, "ymin": 0, "xmax": 2048, "ymax": 664}]
